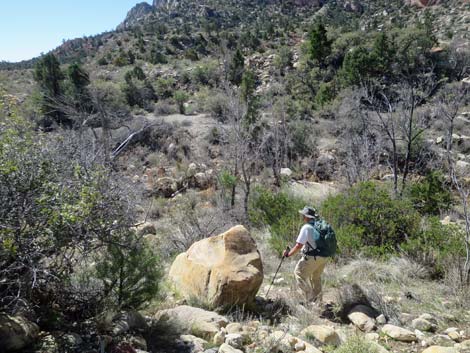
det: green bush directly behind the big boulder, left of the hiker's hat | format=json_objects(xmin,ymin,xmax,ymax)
[{"xmin": 249, "ymin": 187, "xmax": 305, "ymax": 254}]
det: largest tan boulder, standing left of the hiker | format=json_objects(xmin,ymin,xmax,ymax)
[{"xmin": 169, "ymin": 226, "xmax": 263, "ymax": 306}]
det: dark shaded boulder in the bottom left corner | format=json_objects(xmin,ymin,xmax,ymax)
[{"xmin": 0, "ymin": 314, "xmax": 39, "ymax": 352}]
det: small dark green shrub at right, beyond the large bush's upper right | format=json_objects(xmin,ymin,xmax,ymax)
[{"xmin": 408, "ymin": 171, "xmax": 453, "ymax": 216}]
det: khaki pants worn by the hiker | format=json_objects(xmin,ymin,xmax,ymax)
[{"xmin": 294, "ymin": 256, "xmax": 328, "ymax": 302}]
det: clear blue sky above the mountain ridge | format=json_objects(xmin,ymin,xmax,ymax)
[{"xmin": 0, "ymin": 0, "xmax": 151, "ymax": 62}]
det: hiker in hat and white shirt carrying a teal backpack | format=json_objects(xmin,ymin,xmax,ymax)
[{"xmin": 283, "ymin": 206, "xmax": 336, "ymax": 303}]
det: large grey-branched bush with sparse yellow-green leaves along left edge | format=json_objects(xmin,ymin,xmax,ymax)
[{"xmin": 0, "ymin": 97, "xmax": 160, "ymax": 329}]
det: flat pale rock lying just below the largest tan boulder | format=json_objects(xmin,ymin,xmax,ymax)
[{"xmin": 155, "ymin": 305, "xmax": 228, "ymax": 340}]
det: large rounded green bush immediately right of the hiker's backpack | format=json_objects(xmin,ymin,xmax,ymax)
[{"xmin": 322, "ymin": 182, "xmax": 421, "ymax": 255}]
